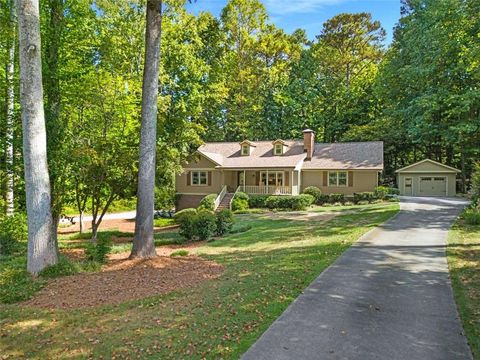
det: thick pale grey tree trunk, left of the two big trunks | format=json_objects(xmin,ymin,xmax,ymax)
[{"xmin": 17, "ymin": 0, "xmax": 58, "ymax": 274}]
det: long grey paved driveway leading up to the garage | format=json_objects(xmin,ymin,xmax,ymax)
[{"xmin": 243, "ymin": 197, "xmax": 472, "ymax": 360}]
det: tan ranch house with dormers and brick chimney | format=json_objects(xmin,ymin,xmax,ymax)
[{"xmin": 176, "ymin": 129, "xmax": 383, "ymax": 209}]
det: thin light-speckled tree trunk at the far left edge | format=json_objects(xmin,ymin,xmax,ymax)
[{"xmin": 5, "ymin": 0, "xmax": 16, "ymax": 216}]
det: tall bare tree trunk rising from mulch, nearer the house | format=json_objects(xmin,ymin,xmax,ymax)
[{"xmin": 130, "ymin": 0, "xmax": 162, "ymax": 258}]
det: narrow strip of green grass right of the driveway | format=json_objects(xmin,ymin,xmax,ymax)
[{"xmin": 447, "ymin": 220, "xmax": 480, "ymax": 360}]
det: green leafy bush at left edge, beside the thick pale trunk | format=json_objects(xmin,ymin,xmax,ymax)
[{"xmin": 0, "ymin": 214, "xmax": 28, "ymax": 255}]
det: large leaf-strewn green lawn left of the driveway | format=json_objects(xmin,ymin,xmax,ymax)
[{"xmin": 0, "ymin": 203, "xmax": 398, "ymax": 359}]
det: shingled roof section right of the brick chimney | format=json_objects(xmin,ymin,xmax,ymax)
[{"xmin": 302, "ymin": 141, "xmax": 383, "ymax": 170}]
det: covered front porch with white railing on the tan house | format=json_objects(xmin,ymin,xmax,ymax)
[{"xmin": 223, "ymin": 169, "xmax": 300, "ymax": 195}]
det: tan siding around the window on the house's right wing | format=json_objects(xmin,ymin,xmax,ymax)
[{"xmin": 301, "ymin": 170, "xmax": 378, "ymax": 195}]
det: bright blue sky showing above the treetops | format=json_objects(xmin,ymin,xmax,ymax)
[{"xmin": 187, "ymin": 0, "xmax": 400, "ymax": 44}]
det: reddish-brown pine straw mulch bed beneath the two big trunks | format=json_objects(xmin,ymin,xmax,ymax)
[{"xmin": 23, "ymin": 253, "xmax": 223, "ymax": 309}]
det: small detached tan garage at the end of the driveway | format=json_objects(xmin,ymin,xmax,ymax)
[{"xmin": 396, "ymin": 159, "xmax": 460, "ymax": 196}]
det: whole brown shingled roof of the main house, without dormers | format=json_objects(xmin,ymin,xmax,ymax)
[{"xmin": 198, "ymin": 140, "xmax": 383, "ymax": 170}]
